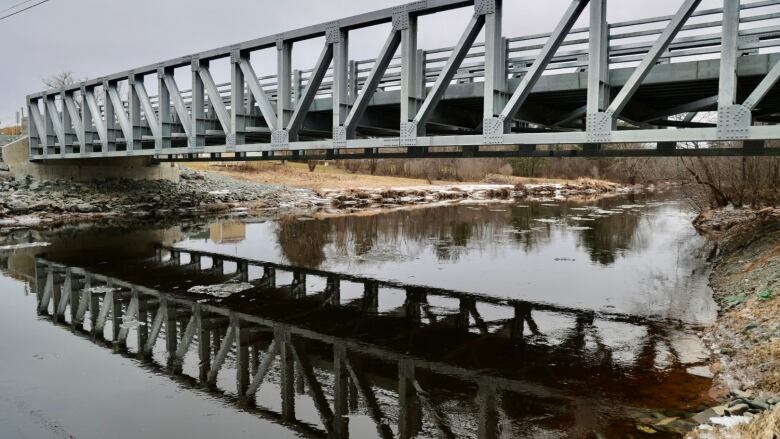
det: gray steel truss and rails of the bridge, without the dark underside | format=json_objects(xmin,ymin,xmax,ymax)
[{"xmin": 22, "ymin": 0, "xmax": 780, "ymax": 159}]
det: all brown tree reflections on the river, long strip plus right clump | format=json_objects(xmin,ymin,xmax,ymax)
[{"xmin": 278, "ymin": 199, "xmax": 642, "ymax": 267}]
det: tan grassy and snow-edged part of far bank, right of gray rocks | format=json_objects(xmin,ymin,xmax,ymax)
[{"xmin": 188, "ymin": 162, "xmax": 636, "ymax": 215}]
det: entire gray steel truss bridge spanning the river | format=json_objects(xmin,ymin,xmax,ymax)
[{"xmin": 27, "ymin": 0, "xmax": 780, "ymax": 161}]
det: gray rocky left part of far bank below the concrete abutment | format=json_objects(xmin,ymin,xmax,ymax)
[{"xmin": 0, "ymin": 168, "xmax": 317, "ymax": 228}]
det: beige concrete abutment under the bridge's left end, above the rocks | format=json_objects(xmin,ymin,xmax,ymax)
[{"xmin": 3, "ymin": 137, "xmax": 179, "ymax": 181}]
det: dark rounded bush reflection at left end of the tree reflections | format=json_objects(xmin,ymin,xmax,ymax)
[{"xmin": 277, "ymin": 217, "xmax": 331, "ymax": 267}]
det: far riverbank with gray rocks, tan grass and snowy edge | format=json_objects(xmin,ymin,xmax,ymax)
[{"xmin": 0, "ymin": 163, "xmax": 635, "ymax": 229}]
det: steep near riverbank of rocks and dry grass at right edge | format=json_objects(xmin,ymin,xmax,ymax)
[{"xmin": 690, "ymin": 208, "xmax": 780, "ymax": 438}]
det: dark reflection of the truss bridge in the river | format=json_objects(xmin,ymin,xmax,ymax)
[{"xmin": 35, "ymin": 247, "xmax": 709, "ymax": 438}]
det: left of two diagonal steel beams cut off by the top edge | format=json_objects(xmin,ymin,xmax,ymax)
[{"xmin": 499, "ymin": 0, "xmax": 588, "ymax": 125}]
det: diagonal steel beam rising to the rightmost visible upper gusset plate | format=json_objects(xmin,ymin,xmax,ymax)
[{"xmin": 413, "ymin": 15, "xmax": 485, "ymax": 134}]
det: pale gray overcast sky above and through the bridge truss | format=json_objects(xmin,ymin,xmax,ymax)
[{"xmin": 0, "ymin": 0, "xmax": 721, "ymax": 126}]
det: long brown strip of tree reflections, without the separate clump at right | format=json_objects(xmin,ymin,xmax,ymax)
[{"xmin": 278, "ymin": 205, "xmax": 545, "ymax": 266}]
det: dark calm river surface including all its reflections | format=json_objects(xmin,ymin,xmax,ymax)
[{"xmin": 0, "ymin": 196, "xmax": 715, "ymax": 438}]
